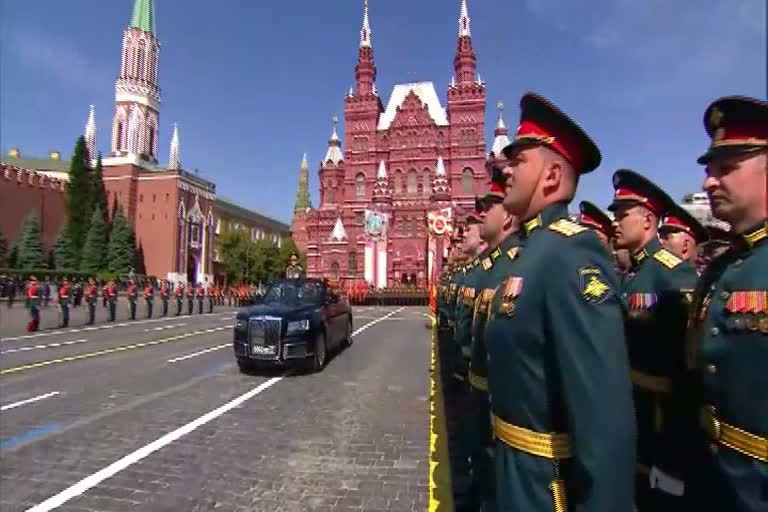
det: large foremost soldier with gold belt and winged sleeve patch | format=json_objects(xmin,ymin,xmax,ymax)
[{"xmin": 485, "ymin": 93, "xmax": 635, "ymax": 512}]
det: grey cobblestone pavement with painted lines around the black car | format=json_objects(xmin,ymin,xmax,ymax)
[{"xmin": 0, "ymin": 307, "xmax": 429, "ymax": 512}]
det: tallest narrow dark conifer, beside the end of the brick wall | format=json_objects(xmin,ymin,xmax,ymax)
[{"xmin": 67, "ymin": 135, "xmax": 93, "ymax": 264}]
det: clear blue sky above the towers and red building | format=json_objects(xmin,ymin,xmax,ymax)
[{"xmin": 0, "ymin": 0, "xmax": 767, "ymax": 221}]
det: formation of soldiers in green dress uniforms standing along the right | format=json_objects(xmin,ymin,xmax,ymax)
[{"xmin": 437, "ymin": 93, "xmax": 768, "ymax": 512}]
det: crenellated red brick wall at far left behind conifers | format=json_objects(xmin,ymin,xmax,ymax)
[{"xmin": 0, "ymin": 164, "xmax": 67, "ymax": 252}]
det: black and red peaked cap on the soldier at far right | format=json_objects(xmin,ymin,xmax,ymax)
[{"xmin": 698, "ymin": 96, "xmax": 768, "ymax": 164}]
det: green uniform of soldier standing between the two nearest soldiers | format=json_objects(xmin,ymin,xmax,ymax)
[{"xmin": 621, "ymin": 236, "xmax": 698, "ymax": 496}]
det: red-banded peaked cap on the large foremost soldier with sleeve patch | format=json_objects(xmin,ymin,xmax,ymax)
[{"xmin": 503, "ymin": 92, "xmax": 602, "ymax": 174}]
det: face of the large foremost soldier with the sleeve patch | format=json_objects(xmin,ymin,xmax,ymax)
[{"xmin": 502, "ymin": 147, "xmax": 544, "ymax": 219}]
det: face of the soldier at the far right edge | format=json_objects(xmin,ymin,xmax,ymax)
[{"xmin": 702, "ymin": 151, "xmax": 768, "ymax": 228}]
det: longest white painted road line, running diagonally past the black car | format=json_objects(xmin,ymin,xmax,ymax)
[{"xmin": 27, "ymin": 308, "xmax": 405, "ymax": 512}]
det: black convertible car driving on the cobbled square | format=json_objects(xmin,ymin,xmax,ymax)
[{"xmin": 234, "ymin": 279, "xmax": 352, "ymax": 372}]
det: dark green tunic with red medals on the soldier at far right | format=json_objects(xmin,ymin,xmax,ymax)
[{"xmin": 687, "ymin": 219, "xmax": 768, "ymax": 512}]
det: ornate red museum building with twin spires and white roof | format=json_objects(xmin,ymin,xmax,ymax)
[{"xmin": 291, "ymin": 0, "xmax": 508, "ymax": 288}]
